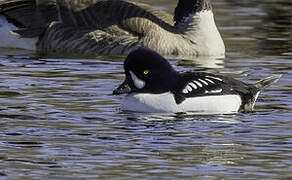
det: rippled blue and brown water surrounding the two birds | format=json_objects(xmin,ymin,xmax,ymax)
[{"xmin": 0, "ymin": 0, "xmax": 292, "ymax": 179}]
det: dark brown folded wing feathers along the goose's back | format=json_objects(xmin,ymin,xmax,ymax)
[{"xmin": 57, "ymin": 0, "xmax": 174, "ymax": 30}]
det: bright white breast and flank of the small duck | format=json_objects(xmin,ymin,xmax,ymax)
[{"xmin": 121, "ymin": 93, "xmax": 242, "ymax": 114}]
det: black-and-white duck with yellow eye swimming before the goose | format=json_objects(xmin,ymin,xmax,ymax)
[{"xmin": 113, "ymin": 48, "xmax": 281, "ymax": 114}]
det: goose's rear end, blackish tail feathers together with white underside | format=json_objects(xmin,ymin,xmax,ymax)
[{"xmin": 0, "ymin": 0, "xmax": 56, "ymax": 51}]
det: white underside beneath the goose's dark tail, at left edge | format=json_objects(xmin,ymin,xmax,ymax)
[{"xmin": 0, "ymin": 15, "xmax": 38, "ymax": 51}]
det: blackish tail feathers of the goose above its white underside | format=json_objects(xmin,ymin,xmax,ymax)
[{"xmin": 0, "ymin": 0, "xmax": 57, "ymax": 38}]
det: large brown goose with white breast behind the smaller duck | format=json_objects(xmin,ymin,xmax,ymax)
[{"xmin": 0, "ymin": 0, "xmax": 225, "ymax": 56}]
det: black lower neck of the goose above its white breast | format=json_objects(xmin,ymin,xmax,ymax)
[{"xmin": 174, "ymin": 0, "xmax": 212, "ymax": 23}]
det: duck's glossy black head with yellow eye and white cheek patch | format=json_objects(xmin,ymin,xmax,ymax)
[{"xmin": 113, "ymin": 48, "xmax": 179, "ymax": 94}]
